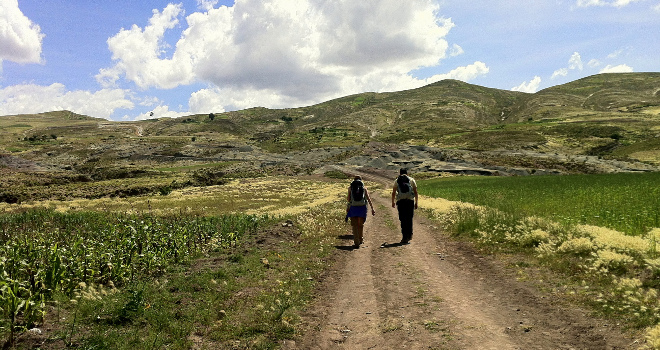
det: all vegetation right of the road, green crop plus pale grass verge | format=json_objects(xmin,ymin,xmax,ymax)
[{"xmin": 418, "ymin": 173, "xmax": 660, "ymax": 334}]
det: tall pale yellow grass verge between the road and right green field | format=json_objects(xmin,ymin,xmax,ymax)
[{"xmin": 420, "ymin": 198, "xmax": 660, "ymax": 349}]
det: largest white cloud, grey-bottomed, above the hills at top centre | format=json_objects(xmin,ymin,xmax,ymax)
[{"xmin": 97, "ymin": 0, "xmax": 458, "ymax": 110}]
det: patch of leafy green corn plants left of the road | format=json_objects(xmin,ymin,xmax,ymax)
[{"xmin": 0, "ymin": 209, "xmax": 268, "ymax": 343}]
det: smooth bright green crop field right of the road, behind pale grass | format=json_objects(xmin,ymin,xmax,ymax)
[{"xmin": 420, "ymin": 173, "xmax": 660, "ymax": 235}]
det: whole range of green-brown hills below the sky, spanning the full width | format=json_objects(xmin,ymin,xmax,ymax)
[{"xmin": 0, "ymin": 73, "xmax": 660, "ymax": 202}]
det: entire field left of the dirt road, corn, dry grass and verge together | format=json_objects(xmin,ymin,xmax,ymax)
[{"xmin": 0, "ymin": 177, "xmax": 345, "ymax": 349}]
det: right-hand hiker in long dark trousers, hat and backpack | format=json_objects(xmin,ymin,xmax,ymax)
[{"xmin": 392, "ymin": 168, "xmax": 419, "ymax": 244}]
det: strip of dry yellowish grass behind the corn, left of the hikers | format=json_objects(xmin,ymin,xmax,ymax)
[{"xmin": 0, "ymin": 177, "xmax": 346, "ymax": 216}]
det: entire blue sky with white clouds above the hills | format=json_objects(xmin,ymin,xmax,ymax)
[{"xmin": 0, "ymin": 0, "xmax": 660, "ymax": 121}]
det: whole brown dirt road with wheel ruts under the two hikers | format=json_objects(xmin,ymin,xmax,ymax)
[{"xmin": 284, "ymin": 172, "xmax": 636, "ymax": 349}]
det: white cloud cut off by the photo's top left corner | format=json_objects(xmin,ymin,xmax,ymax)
[{"xmin": 0, "ymin": 0, "xmax": 44, "ymax": 69}]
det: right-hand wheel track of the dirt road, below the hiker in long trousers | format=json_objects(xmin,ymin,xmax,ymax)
[{"xmin": 368, "ymin": 194, "xmax": 516, "ymax": 349}]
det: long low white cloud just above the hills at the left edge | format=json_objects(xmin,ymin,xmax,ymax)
[{"xmin": 0, "ymin": 83, "xmax": 134, "ymax": 119}]
